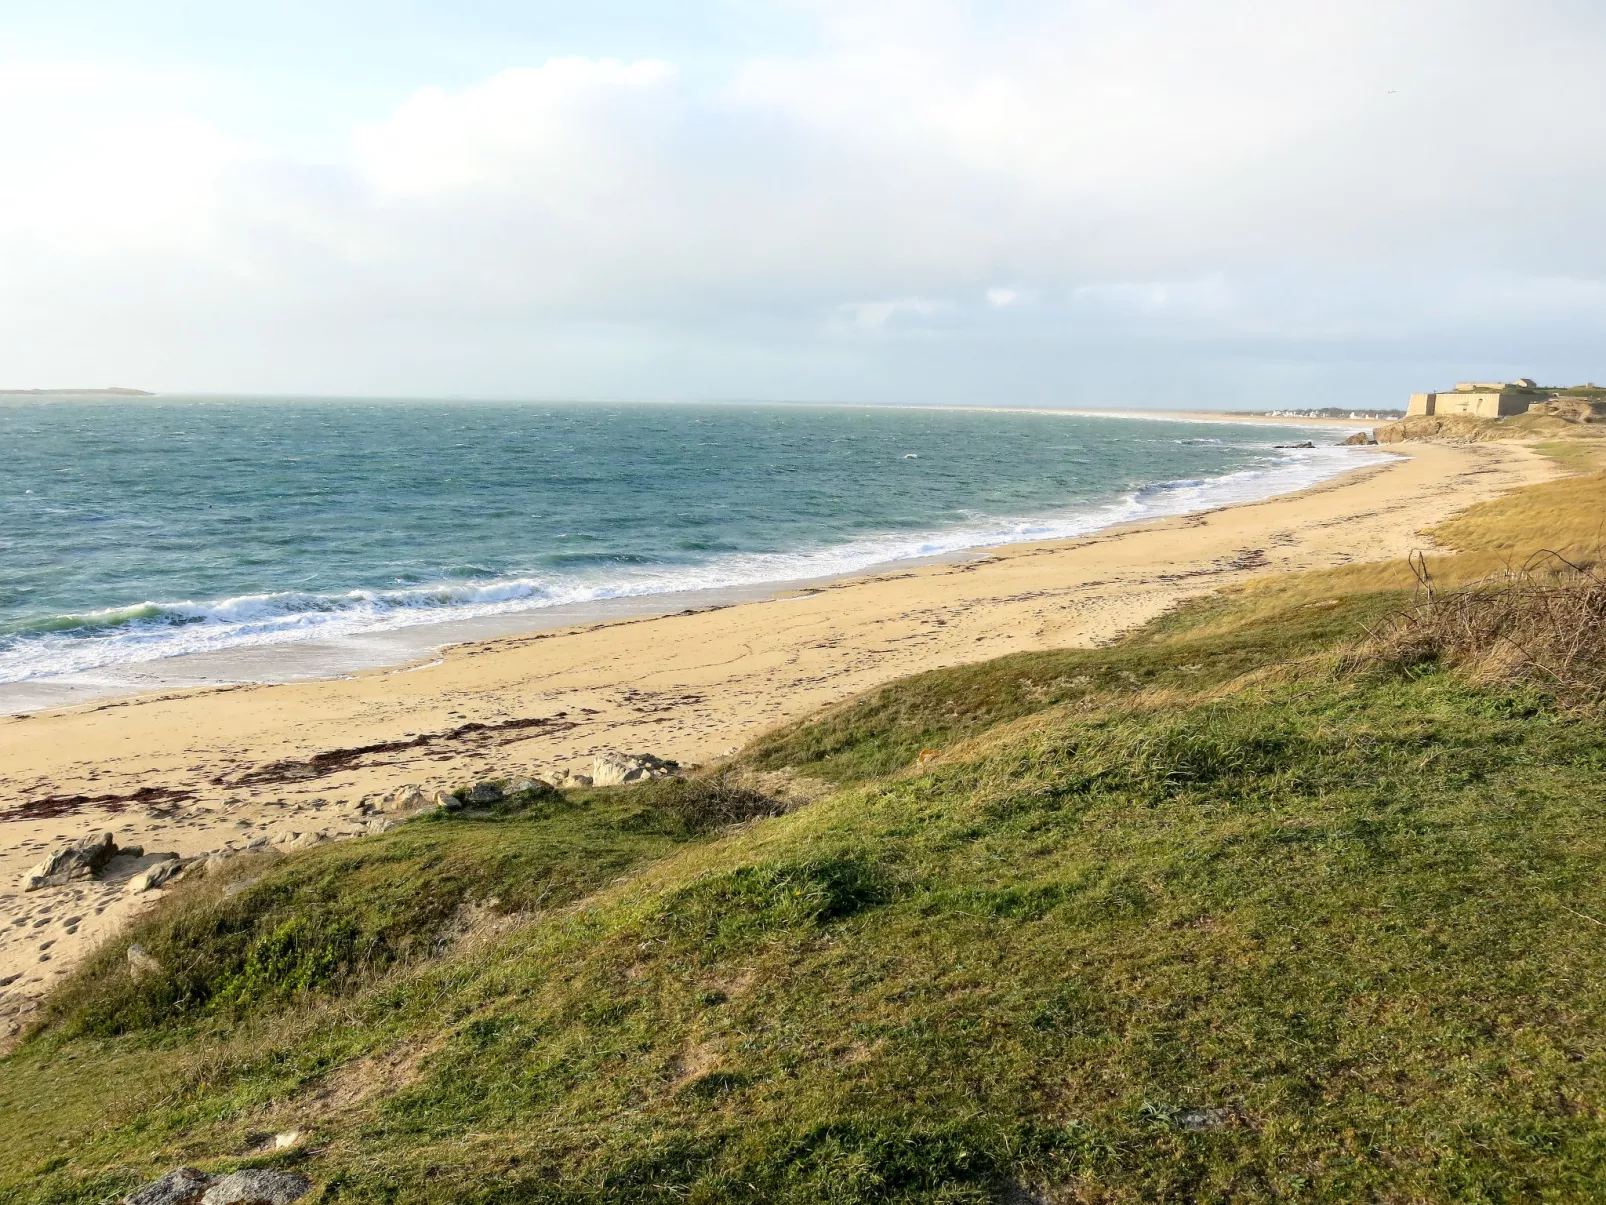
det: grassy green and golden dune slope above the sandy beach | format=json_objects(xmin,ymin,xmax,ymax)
[{"xmin": 9, "ymin": 476, "xmax": 1606, "ymax": 1205}]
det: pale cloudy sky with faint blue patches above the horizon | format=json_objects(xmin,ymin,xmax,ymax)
[{"xmin": 0, "ymin": 0, "xmax": 1606, "ymax": 408}]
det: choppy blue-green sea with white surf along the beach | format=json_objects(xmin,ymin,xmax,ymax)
[{"xmin": 0, "ymin": 397, "xmax": 1360, "ymax": 704}]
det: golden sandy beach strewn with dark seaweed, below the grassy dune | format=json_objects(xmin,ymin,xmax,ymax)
[{"xmin": 0, "ymin": 443, "xmax": 1558, "ymax": 1041}]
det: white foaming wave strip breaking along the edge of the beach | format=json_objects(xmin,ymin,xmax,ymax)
[{"xmin": 0, "ymin": 447, "xmax": 1365, "ymax": 683}]
